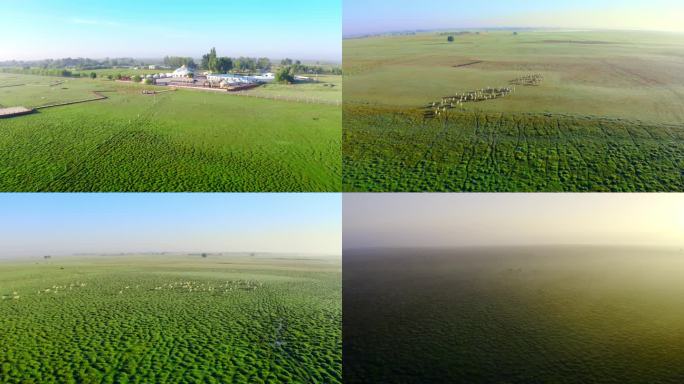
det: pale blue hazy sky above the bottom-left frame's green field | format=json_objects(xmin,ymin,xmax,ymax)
[{"xmin": 0, "ymin": 193, "xmax": 342, "ymax": 258}]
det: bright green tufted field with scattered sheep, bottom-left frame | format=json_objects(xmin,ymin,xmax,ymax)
[{"xmin": 0, "ymin": 255, "xmax": 342, "ymax": 383}]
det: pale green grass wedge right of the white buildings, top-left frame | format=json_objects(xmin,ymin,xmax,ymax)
[{"xmin": 244, "ymin": 75, "xmax": 342, "ymax": 105}]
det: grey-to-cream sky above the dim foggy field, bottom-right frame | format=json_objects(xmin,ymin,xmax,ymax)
[{"xmin": 343, "ymin": 193, "xmax": 684, "ymax": 249}]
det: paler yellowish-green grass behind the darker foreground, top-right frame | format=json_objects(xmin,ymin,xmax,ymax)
[{"xmin": 344, "ymin": 31, "xmax": 684, "ymax": 123}]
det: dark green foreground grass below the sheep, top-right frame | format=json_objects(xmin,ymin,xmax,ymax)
[{"xmin": 343, "ymin": 107, "xmax": 684, "ymax": 192}]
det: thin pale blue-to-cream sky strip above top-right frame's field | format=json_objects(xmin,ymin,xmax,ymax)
[{"xmin": 343, "ymin": 0, "xmax": 684, "ymax": 36}]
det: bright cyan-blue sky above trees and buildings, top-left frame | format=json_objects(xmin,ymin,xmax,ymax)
[{"xmin": 0, "ymin": 0, "xmax": 342, "ymax": 61}]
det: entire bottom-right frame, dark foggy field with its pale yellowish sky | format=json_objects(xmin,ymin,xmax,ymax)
[{"xmin": 343, "ymin": 194, "xmax": 684, "ymax": 384}]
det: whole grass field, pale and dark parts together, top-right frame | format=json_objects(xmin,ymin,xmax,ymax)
[{"xmin": 343, "ymin": 31, "xmax": 684, "ymax": 191}]
